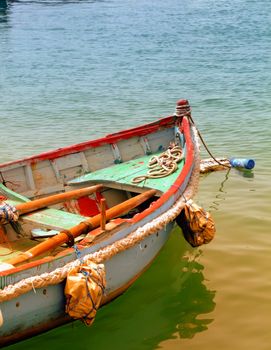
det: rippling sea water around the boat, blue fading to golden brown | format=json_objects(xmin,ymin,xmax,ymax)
[{"xmin": 0, "ymin": 0, "xmax": 271, "ymax": 350}]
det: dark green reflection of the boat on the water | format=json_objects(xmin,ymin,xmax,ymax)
[{"xmin": 27, "ymin": 228, "xmax": 216, "ymax": 349}]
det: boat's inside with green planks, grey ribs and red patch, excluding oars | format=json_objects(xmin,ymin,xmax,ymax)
[{"xmin": 0, "ymin": 126, "xmax": 185, "ymax": 262}]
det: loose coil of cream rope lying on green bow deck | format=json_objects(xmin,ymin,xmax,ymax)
[{"xmin": 132, "ymin": 143, "xmax": 184, "ymax": 184}]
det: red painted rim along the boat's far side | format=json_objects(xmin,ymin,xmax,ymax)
[{"xmin": 0, "ymin": 116, "xmax": 176, "ymax": 168}]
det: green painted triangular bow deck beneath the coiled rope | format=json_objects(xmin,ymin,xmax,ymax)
[{"xmin": 69, "ymin": 153, "xmax": 184, "ymax": 193}]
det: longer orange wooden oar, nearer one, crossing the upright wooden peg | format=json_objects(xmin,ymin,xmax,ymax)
[{"xmin": 6, "ymin": 190, "xmax": 156, "ymax": 265}]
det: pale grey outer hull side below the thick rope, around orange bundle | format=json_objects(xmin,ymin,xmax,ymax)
[{"xmin": 0, "ymin": 223, "xmax": 173, "ymax": 345}]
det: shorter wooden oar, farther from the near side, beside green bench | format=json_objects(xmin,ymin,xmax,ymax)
[{"xmin": 16, "ymin": 185, "xmax": 103, "ymax": 215}]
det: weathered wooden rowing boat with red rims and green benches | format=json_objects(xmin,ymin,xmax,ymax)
[{"xmin": 0, "ymin": 100, "xmax": 204, "ymax": 345}]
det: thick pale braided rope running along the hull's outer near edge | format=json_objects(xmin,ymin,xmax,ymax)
[{"xmin": 0, "ymin": 126, "xmax": 200, "ymax": 302}]
